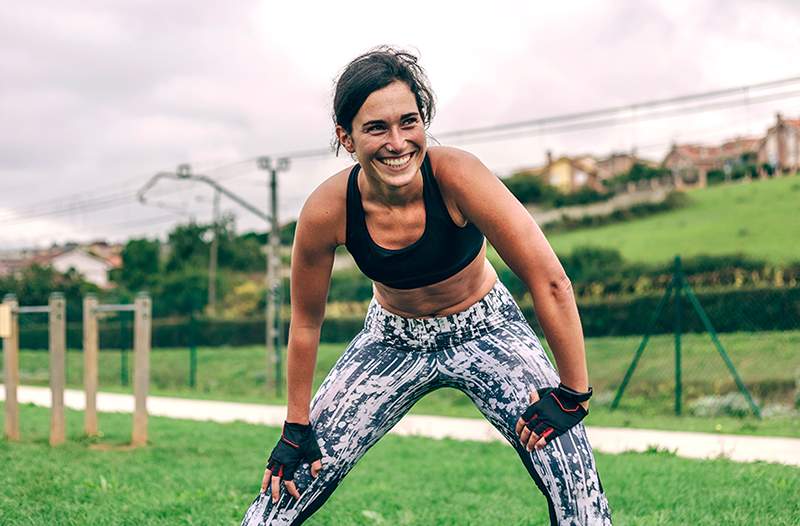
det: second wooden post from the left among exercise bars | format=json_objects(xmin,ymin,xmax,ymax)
[{"xmin": 48, "ymin": 292, "xmax": 67, "ymax": 446}]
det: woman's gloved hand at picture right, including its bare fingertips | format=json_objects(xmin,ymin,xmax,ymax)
[{"xmin": 515, "ymin": 384, "xmax": 592, "ymax": 451}]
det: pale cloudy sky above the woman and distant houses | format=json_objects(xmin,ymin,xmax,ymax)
[{"xmin": 0, "ymin": 0, "xmax": 800, "ymax": 249}]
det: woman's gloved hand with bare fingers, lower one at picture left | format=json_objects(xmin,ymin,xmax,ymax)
[{"xmin": 261, "ymin": 422, "xmax": 322, "ymax": 503}]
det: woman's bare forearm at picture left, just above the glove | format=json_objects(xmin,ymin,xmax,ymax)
[{"xmin": 286, "ymin": 327, "xmax": 320, "ymax": 424}]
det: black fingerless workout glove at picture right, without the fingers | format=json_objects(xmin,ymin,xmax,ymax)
[{"xmin": 522, "ymin": 384, "xmax": 592, "ymax": 444}]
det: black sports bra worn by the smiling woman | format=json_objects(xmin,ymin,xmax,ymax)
[{"xmin": 345, "ymin": 155, "xmax": 483, "ymax": 289}]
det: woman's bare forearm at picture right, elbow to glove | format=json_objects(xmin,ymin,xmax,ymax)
[{"xmin": 531, "ymin": 277, "xmax": 589, "ymax": 392}]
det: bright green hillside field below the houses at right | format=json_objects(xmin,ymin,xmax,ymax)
[{"xmin": 536, "ymin": 176, "xmax": 800, "ymax": 263}]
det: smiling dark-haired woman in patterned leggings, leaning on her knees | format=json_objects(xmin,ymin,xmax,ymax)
[{"xmin": 242, "ymin": 48, "xmax": 611, "ymax": 526}]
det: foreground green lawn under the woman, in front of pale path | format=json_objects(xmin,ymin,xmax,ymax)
[{"xmin": 0, "ymin": 404, "xmax": 800, "ymax": 526}]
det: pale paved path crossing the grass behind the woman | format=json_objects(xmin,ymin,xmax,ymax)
[{"xmin": 0, "ymin": 384, "xmax": 800, "ymax": 466}]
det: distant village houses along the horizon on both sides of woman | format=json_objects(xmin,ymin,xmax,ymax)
[{"xmin": 0, "ymin": 114, "xmax": 800, "ymax": 289}]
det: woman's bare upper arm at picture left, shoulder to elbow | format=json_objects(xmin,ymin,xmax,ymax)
[{"xmin": 290, "ymin": 180, "xmax": 343, "ymax": 328}]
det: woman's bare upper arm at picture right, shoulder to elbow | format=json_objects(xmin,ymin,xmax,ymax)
[{"xmin": 431, "ymin": 148, "xmax": 566, "ymax": 289}]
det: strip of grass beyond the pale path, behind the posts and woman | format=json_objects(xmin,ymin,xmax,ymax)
[{"xmin": 7, "ymin": 331, "xmax": 800, "ymax": 436}]
